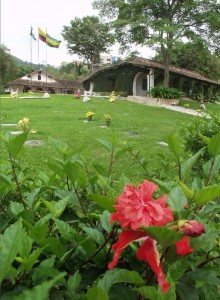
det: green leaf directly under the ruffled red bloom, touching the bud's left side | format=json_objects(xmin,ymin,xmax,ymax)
[{"xmin": 142, "ymin": 226, "xmax": 183, "ymax": 247}]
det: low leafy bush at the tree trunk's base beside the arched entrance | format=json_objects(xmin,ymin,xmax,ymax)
[{"xmin": 148, "ymin": 85, "xmax": 184, "ymax": 99}]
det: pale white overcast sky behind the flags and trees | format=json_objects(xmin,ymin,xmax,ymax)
[{"xmin": 0, "ymin": 0, "xmax": 152, "ymax": 66}]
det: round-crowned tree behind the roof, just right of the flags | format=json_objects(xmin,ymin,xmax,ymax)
[{"xmin": 62, "ymin": 16, "xmax": 114, "ymax": 71}]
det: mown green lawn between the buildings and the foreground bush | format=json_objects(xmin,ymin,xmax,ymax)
[{"xmin": 1, "ymin": 95, "xmax": 218, "ymax": 178}]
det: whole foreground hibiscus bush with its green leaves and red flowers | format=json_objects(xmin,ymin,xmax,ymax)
[{"xmin": 0, "ymin": 131, "xmax": 220, "ymax": 300}]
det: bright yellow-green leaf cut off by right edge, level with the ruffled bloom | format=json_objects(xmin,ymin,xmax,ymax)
[{"xmin": 194, "ymin": 185, "xmax": 220, "ymax": 206}]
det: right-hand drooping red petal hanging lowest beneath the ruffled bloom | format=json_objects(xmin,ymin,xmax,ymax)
[{"xmin": 137, "ymin": 237, "xmax": 170, "ymax": 293}]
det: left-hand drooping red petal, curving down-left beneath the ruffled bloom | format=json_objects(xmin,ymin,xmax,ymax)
[{"xmin": 108, "ymin": 230, "xmax": 147, "ymax": 269}]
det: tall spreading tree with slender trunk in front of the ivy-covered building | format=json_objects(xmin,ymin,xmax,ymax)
[{"xmin": 93, "ymin": 0, "xmax": 220, "ymax": 86}]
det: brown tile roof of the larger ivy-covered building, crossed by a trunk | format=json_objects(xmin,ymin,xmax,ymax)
[{"xmin": 83, "ymin": 57, "xmax": 220, "ymax": 86}]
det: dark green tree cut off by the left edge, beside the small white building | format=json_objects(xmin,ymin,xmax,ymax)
[{"xmin": 0, "ymin": 45, "xmax": 18, "ymax": 91}]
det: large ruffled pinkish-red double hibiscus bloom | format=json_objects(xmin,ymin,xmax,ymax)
[{"xmin": 110, "ymin": 180, "xmax": 173, "ymax": 230}]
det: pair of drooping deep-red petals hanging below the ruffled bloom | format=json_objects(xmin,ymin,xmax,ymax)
[{"xmin": 108, "ymin": 230, "xmax": 170, "ymax": 293}]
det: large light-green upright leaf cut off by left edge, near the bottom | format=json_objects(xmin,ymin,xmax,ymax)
[{"xmin": 0, "ymin": 219, "xmax": 22, "ymax": 283}]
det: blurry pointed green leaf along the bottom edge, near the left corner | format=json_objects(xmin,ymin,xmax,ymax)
[{"xmin": 14, "ymin": 273, "xmax": 66, "ymax": 300}]
